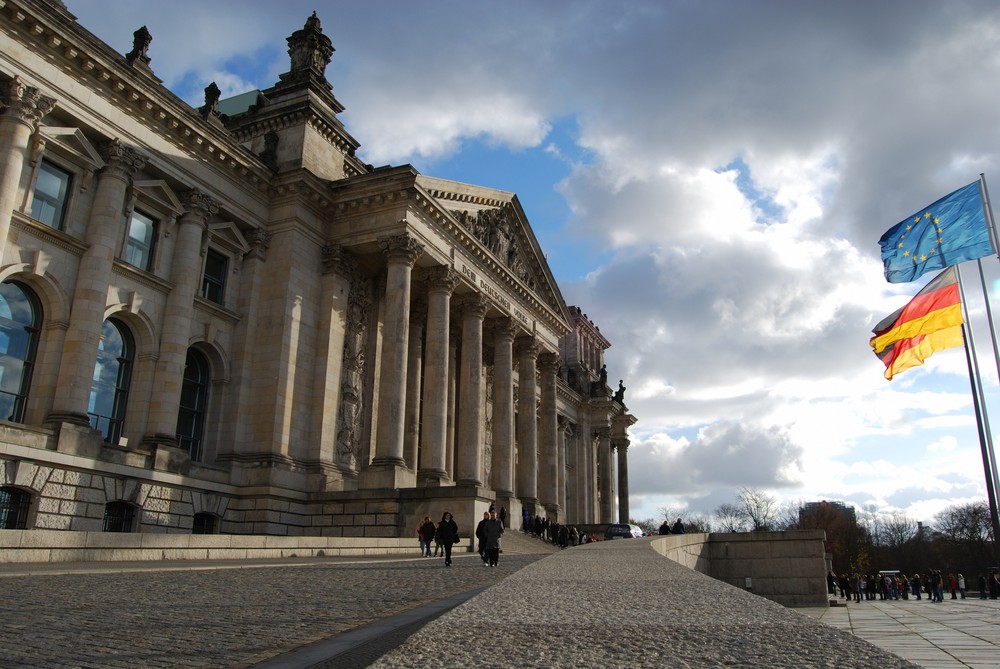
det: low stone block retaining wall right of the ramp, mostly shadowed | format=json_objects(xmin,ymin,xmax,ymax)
[{"xmin": 653, "ymin": 530, "xmax": 829, "ymax": 607}]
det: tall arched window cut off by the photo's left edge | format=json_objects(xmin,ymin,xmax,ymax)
[{"xmin": 0, "ymin": 282, "xmax": 42, "ymax": 423}]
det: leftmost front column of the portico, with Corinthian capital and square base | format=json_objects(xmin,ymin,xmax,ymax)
[{"xmin": 362, "ymin": 234, "xmax": 424, "ymax": 488}]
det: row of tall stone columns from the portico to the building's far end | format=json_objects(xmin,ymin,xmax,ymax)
[{"xmin": 359, "ymin": 233, "xmax": 628, "ymax": 523}]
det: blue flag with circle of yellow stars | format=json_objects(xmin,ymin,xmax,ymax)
[{"xmin": 878, "ymin": 181, "xmax": 993, "ymax": 283}]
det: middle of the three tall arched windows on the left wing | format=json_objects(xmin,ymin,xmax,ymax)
[{"xmin": 87, "ymin": 318, "xmax": 135, "ymax": 444}]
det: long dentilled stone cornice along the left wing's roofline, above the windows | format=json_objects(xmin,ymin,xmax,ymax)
[{"xmin": 0, "ymin": 0, "xmax": 271, "ymax": 189}]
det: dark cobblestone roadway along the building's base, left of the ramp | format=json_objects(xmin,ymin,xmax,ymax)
[{"xmin": 0, "ymin": 554, "xmax": 544, "ymax": 669}]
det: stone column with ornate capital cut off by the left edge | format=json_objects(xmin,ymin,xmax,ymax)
[{"xmin": 0, "ymin": 77, "xmax": 55, "ymax": 258}]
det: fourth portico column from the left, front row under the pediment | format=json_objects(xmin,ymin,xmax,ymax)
[{"xmin": 490, "ymin": 318, "xmax": 514, "ymax": 500}]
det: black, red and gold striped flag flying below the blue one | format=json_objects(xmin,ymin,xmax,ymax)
[{"xmin": 869, "ymin": 267, "xmax": 964, "ymax": 379}]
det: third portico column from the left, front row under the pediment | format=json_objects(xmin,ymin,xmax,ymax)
[{"xmin": 455, "ymin": 293, "xmax": 489, "ymax": 486}]
